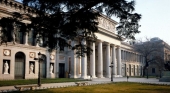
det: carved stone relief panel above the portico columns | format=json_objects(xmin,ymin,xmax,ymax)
[{"xmin": 98, "ymin": 17, "xmax": 115, "ymax": 33}]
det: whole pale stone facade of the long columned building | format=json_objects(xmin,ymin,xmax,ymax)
[{"xmin": 0, "ymin": 0, "xmax": 144, "ymax": 80}]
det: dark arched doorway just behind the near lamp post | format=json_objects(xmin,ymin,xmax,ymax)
[{"xmin": 40, "ymin": 55, "xmax": 47, "ymax": 78}]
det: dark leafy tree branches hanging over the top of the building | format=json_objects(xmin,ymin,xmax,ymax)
[{"xmin": 0, "ymin": 0, "xmax": 141, "ymax": 56}]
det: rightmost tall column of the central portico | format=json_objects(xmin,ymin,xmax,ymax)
[{"xmin": 117, "ymin": 46, "xmax": 122, "ymax": 76}]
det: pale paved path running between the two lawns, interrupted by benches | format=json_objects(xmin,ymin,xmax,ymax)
[{"xmin": 0, "ymin": 77, "xmax": 170, "ymax": 92}]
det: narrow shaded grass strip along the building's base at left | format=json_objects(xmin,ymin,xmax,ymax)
[{"xmin": 0, "ymin": 78, "xmax": 86, "ymax": 87}]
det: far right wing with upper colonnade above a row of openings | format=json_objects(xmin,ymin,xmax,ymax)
[{"xmin": 121, "ymin": 49, "xmax": 144, "ymax": 76}]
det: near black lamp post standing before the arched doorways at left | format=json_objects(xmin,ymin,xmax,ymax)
[{"xmin": 34, "ymin": 52, "xmax": 43, "ymax": 86}]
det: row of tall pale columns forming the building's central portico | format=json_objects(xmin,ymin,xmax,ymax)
[{"xmin": 71, "ymin": 40, "xmax": 122, "ymax": 79}]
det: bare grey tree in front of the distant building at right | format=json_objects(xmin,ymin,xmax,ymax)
[{"xmin": 134, "ymin": 38, "xmax": 164, "ymax": 76}]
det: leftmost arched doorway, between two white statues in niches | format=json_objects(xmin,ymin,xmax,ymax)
[{"xmin": 15, "ymin": 52, "xmax": 25, "ymax": 79}]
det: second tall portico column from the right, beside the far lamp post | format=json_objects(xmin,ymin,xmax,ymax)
[{"xmin": 112, "ymin": 45, "xmax": 117, "ymax": 76}]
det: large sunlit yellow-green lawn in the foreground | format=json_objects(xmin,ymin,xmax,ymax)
[{"xmin": 11, "ymin": 82, "xmax": 170, "ymax": 93}]
